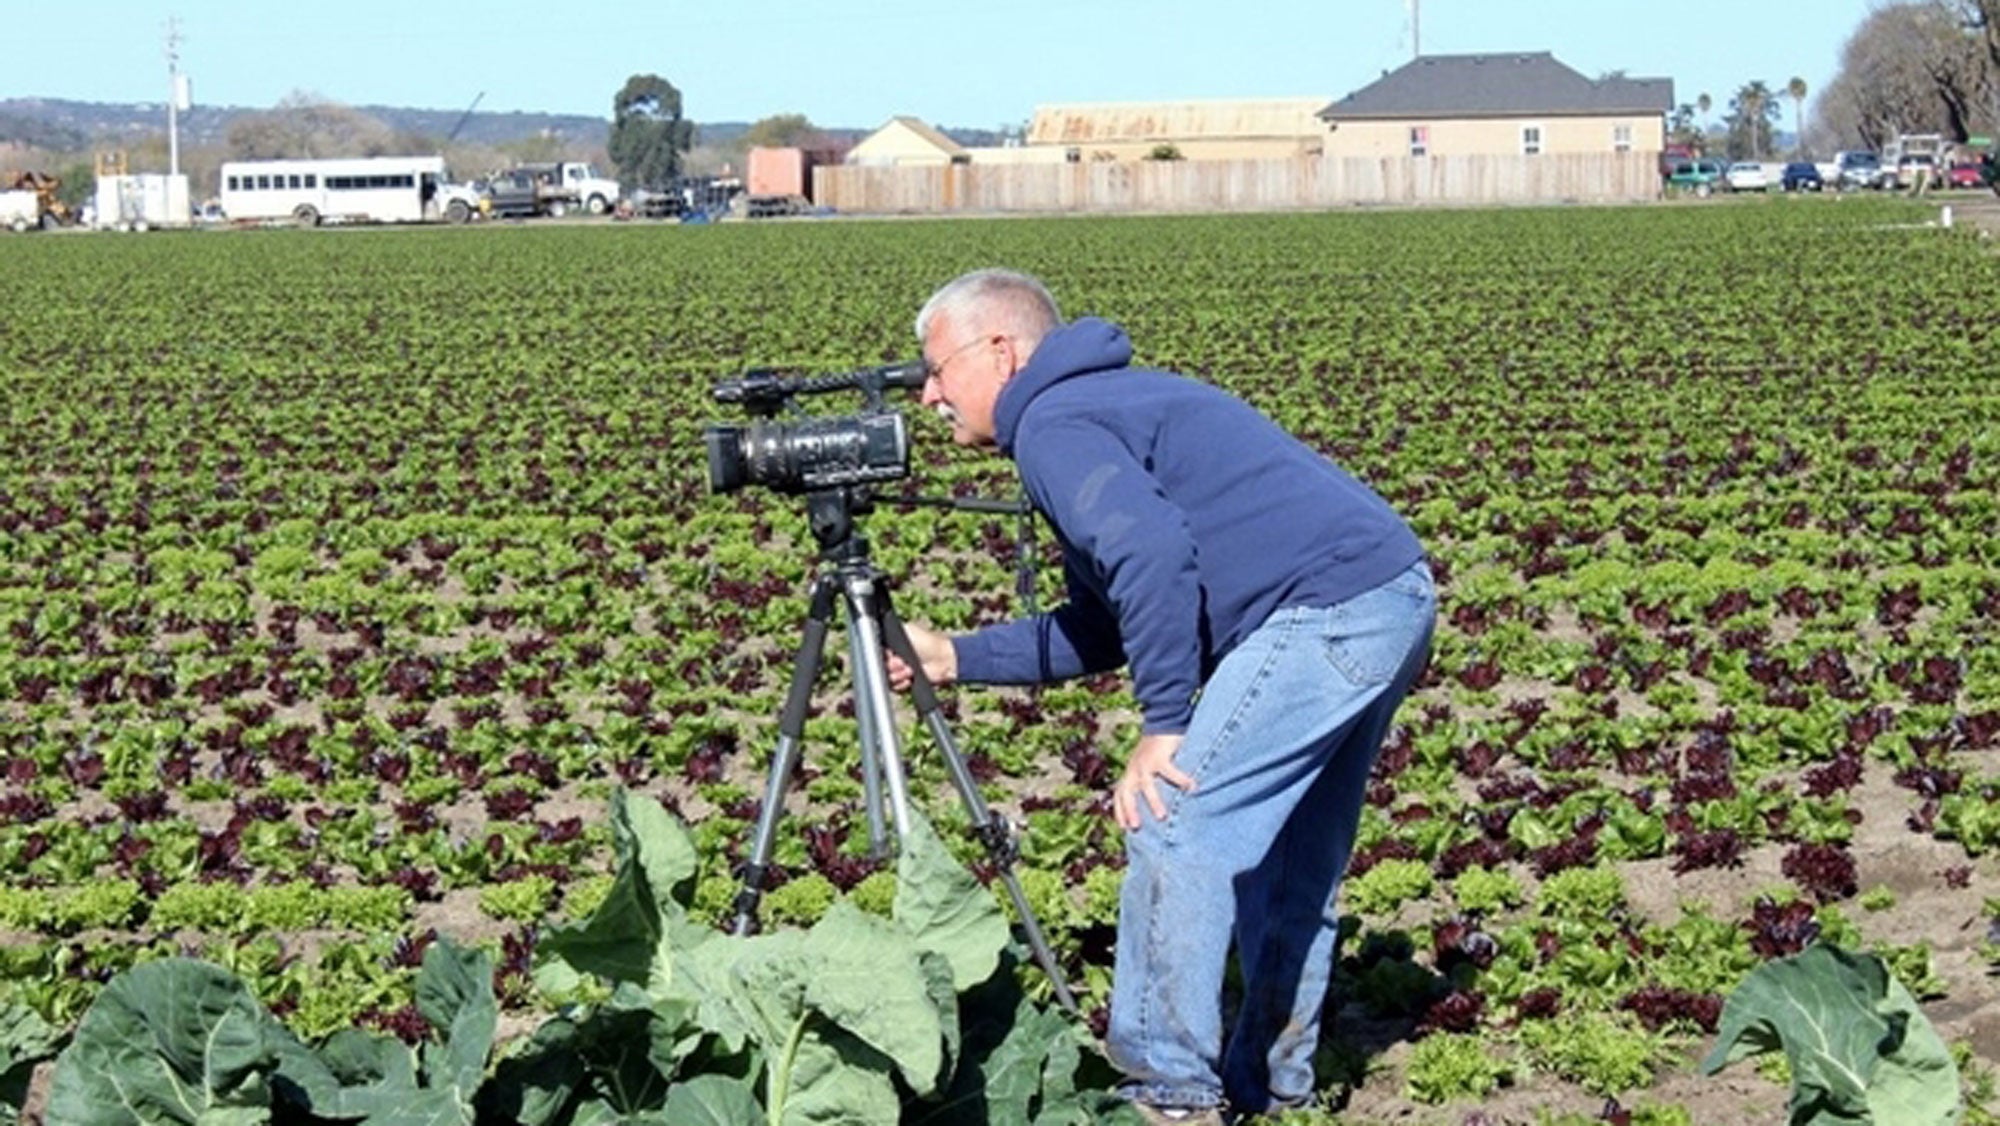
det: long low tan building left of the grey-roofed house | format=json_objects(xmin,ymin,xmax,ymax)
[{"xmin": 1026, "ymin": 98, "xmax": 1326, "ymax": 162}]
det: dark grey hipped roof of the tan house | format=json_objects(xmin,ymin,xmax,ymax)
[{"xmin": 1318, "ymin": 50, "xmax": 1674, "ymax": 122}]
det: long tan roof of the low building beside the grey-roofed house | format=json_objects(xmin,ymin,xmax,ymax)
[{"xmin": 1028, "ymin": 98, "xmax": 1326, "ymax": 144}]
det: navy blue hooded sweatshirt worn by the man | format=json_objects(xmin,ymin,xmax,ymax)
[{"xmin": 956, "ymin": 318, "xmax": 1422, "ymax": 734}]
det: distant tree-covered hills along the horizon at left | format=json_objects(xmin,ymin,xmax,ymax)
[{"xmin": 0, "ymin": 98, "xmax": 1016, "ymax": 150}]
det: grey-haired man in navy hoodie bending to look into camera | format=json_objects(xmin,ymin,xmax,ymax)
[{"xmin": 890, "ymin": 270, "xmax": 1436, "ymax": 1122}]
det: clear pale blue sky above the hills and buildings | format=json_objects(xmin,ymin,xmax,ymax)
[{"xmin": 0, "ymin": 0, "xmax": 1874, "ymax": 128}]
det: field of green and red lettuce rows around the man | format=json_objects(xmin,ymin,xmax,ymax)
[{"xmin": 0, "ymin": 198, "xmax": 2000, "ymax": 1126}]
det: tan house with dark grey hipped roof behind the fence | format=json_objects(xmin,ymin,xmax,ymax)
[{"xmin": 1316, "ymin": 52, "xmax": 1674, "ymax": 156}]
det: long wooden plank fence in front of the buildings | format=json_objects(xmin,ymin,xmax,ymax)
[{"xmin": 812, "ymin": 152, "xmax": 1660, "ymax": 214}]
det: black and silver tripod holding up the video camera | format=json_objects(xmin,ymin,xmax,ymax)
[{"xmin": 734, "ymin": 488, "xmax": 1076, "ymax": 1014}]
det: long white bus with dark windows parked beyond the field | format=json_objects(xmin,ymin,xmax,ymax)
[{"xmin": 220, "ymin": 156, "xmax": 446, "ymax": 226}]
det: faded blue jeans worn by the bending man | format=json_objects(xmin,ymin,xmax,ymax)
[{"xmin": 1106, "ymin": 562, "xmax": 1436, "ymax": 1112}]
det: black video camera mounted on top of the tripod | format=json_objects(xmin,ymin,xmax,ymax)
[{"xmin": 702, "ymin": 360, "xmax": 926, "ymax": 492}]
